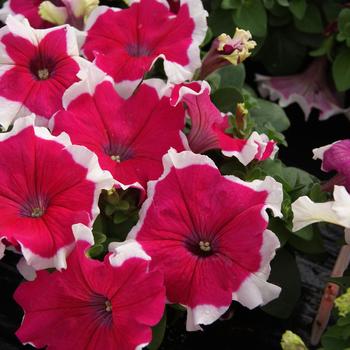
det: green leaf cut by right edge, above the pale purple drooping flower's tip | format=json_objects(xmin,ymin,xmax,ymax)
[{"xmin": 332, "ymin": 48, "xmax": 350, "ymax": 91}]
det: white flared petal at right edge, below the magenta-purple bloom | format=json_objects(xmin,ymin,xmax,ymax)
[{"xmin": 292, "ymin": 186, "xmax": 350, "ymax": 237}]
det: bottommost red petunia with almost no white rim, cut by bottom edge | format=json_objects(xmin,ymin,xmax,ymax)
[{"xmin": 14, "ymin": 225, "xmax": 165, "ymax": 350}]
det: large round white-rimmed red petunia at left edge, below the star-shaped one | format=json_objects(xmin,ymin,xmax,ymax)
[{"xmin": 0, "ymin": 116, "xmax": 114, "ymax": 270}]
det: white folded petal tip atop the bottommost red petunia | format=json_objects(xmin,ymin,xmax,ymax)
[{"xmin": 108, "ymin": 239, "xmax": 151, "ymax": 266}]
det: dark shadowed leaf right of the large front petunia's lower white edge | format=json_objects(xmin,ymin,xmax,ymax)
[{"xmin": 262, "ymin": 248, "xmax": 301, "ymax": 319}]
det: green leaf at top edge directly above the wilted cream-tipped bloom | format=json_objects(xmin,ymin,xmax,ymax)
[{"xmin": 233, "ymin": 0, "xmax": 267, "ymax": 37}]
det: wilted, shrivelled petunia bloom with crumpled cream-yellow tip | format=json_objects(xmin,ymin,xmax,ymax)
[{"xmin": 199, "ymin": 28, "xmax": 256, "ymax": 79}]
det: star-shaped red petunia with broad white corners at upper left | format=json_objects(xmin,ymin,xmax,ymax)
[{"xmin": 0, "ymin": 16, "xmax": 89, "ymax": 128}]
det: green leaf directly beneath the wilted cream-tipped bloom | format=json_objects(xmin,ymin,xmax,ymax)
[{"xmin": 206, "ymin": 64, "xmax": 245, "ymax": 92}]
